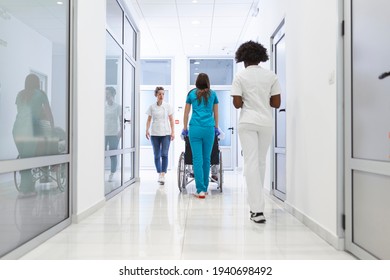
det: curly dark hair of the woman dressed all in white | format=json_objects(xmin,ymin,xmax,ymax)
[{"xmin": 235, "ymin": 41, "xmax": 269, "ymax": 64}]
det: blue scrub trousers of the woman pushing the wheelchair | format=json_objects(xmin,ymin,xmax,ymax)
[{"xmin": 188, "ymin": 126, "xmax": 215, "ymax": 193}]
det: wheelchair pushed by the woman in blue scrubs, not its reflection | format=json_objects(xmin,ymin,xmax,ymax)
[{"xmin": 177, "ymin": 136, "xmax": 223, "ymax": 192}]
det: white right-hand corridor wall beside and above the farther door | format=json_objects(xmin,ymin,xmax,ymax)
[{"xmin": 245, "ymin": 0, "xmax": 340, "ymax": 247}]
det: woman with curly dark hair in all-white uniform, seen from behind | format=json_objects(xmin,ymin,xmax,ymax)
[{"xmin": 231, "ymin": 41, "xmax": 280, "ymax": 223}]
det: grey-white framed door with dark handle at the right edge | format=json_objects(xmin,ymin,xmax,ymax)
[{"xmin": 345, "ymin": 0, "xmax": 390, "ymax": 259}]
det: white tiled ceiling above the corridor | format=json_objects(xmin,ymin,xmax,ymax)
[{"xmin": 131, "ymin": 0, "xmax": 259, "ymax": 57}]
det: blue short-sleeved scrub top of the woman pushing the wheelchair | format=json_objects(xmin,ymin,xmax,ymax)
[{"xmin": 186, "ymin": 88, "xmax": 219, "ymax": 126}]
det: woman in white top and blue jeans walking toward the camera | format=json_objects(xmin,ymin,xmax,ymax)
[{"xmin": 146, "ymin": 87, "xmax": 175, "ymax": 185}]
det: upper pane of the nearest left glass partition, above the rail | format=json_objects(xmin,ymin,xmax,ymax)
[{"xmin": 0, "ymin": 1, "xmax": 69, "ymax": 160}]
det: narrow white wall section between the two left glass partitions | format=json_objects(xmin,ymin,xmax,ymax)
[{"xmin": 72, "ymin": 0, "xmax": 106, "ymax": 220}]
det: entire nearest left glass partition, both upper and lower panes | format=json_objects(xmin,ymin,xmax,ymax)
[{"xmin": 0, "ymin": 0, "xmax": 70, "ymax": 257}]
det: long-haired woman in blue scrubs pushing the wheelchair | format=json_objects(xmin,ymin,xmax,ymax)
[{"xmin": 182, "ymin": 73, "xmax": 219, "ymax": 198}]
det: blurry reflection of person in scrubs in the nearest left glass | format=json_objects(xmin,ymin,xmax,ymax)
[{"xmin": 12, "ymin": 74, "xmax": 54, "ymax": 196}]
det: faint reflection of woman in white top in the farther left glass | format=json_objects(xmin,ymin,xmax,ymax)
[{"xmin": 104, "ymin": 87, "xmax": 122, "ymax": 182}]
